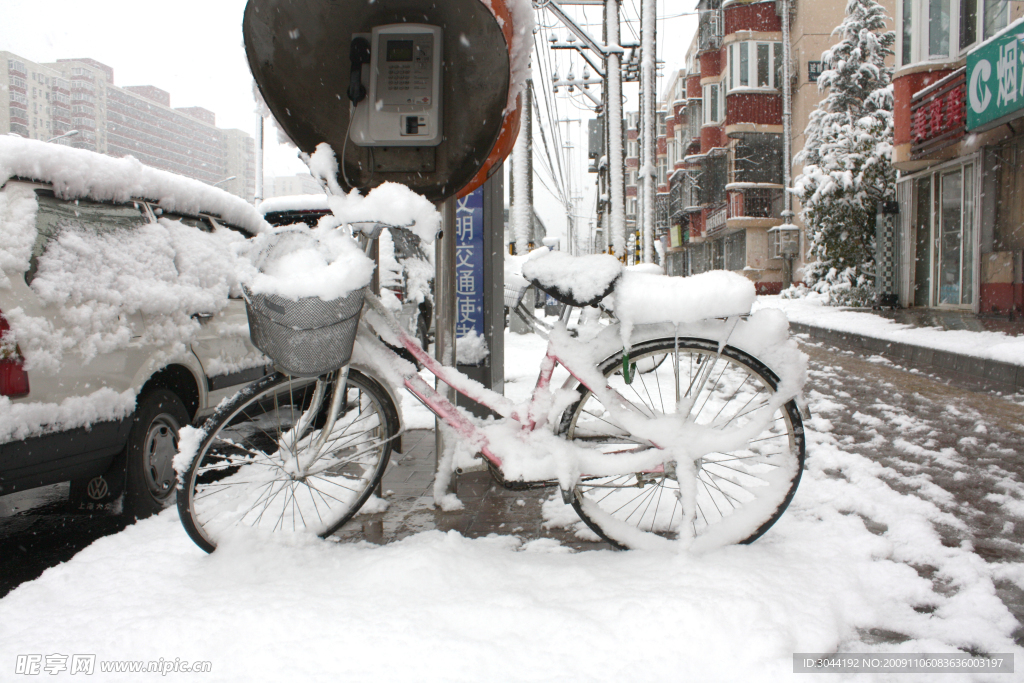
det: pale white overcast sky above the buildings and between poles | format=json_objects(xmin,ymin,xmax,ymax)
[{"xmin": 0, "ymin": 0, "xmax": 696, "ymax": 244}]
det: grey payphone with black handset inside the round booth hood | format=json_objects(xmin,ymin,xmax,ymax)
[{"xmin": 349, "ymin": 24, "xmax": 443, "ymax": 146}]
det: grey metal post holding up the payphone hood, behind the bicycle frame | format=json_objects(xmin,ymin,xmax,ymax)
[{"xmin": 434, "ymin": 197, "xmax": 456, "ymax": 486}]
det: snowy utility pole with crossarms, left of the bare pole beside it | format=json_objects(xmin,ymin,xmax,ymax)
[{"xmin": 604, "ymin": 0, "xmax": 626, "ymax": 258}]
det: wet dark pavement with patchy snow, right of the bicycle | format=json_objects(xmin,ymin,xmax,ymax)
[{"xmin": 798, "ymin": 340, "xmax": 1024, "ymax": 645}]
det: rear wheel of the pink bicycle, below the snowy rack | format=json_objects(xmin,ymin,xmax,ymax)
[{"xmin": 560, "ymin": 338, "xmax": 806, "ymax": 548}]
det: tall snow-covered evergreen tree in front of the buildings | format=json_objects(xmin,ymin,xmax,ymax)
[{"xmin": 794, "ymin": 0, "xmax": 896, "ymax": 304}]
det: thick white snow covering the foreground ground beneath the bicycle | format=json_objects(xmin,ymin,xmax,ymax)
[{"xmin": 0, "ymin": 321, "xmax": 1024, "ymax": 682}]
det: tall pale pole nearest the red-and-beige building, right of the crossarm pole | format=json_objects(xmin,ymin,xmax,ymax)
[{"xmin": 640, "ymin": 0, "xmax": 657, "ymax": 263}]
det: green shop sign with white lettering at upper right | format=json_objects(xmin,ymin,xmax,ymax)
[{"xmin": 967, "ymin": 24, "xmax": 1024, "ymax": 130}]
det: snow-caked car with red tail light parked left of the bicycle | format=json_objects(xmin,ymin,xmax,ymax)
[{"xmin": 0, "ymin": 136, "xmax": 268, "ymax": 517}]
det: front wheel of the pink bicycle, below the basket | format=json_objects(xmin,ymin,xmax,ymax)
[{"xmin": 178, "ymin": 370, "xmax": 398, "ymax": 552}]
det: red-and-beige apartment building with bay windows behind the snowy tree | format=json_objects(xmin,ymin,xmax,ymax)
[{"xmin": 655, "ymin": 0, "xmax": 894, "ymax": 293}]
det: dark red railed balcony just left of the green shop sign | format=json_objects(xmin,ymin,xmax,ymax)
[{"xmin": 910, "ymin": 69, "xmax": 967, "ymax": 159}]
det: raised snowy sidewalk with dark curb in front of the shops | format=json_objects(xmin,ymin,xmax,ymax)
[{"xmin": 755, "ymin": 296, "xmax": 1024, "ymax": 391}]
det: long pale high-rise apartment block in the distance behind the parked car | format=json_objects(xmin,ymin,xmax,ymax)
[{"xmin": 0, "ymin": 51, "xmax": 256, "ymax": 202}]
